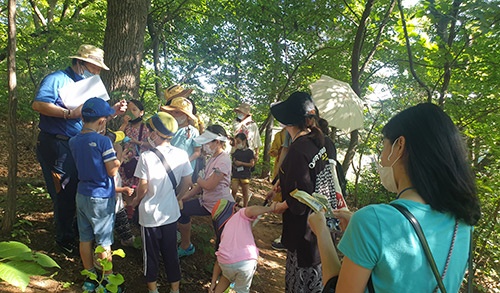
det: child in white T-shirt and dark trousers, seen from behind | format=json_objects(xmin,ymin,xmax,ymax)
[{"xmin": 132, "ymin": 112, "xmax": 193, "ymax": 293}]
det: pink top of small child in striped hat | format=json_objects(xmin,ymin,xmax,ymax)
[{"xmin": 215, "ymin": 208, "xmax": 259, "ymax": 264}]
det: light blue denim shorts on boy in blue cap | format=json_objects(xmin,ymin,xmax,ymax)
[{"xmin": 76, "ymin": 193, "xmax": 116, "ymax": 247}]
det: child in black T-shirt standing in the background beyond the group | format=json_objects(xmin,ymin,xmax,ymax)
[{"xmin": 231, "ymin": 132, "xmax": 255, "ymax": 207}]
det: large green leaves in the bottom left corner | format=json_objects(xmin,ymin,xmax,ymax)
[{"xmin": 0, "ymin": 241, "xmax": 60, "ymax": 292}]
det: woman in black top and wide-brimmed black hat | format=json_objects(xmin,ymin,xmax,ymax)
[{"xmin": 271, "ymin": 92, "xmax": 329, "ymax": 292}]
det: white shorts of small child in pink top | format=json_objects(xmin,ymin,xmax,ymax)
[{"xmin": 219, "ymin": 259, "xmax": 257, "ymax": 293}]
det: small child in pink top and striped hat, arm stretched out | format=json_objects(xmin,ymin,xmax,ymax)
[{"xmin": 210, "ymin": 199, "xmax": 276, "ymax": 293}]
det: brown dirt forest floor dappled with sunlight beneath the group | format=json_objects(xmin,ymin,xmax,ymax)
[{"xmin": 0, "ymin": 122, "xmax": 286, "ymax": 293}]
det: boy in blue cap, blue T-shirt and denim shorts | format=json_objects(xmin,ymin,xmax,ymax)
[{"xmin": 69, "ymin": 98, "xmax": 120, "ymax": 292}]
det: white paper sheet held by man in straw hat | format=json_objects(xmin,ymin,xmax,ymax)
[{"xmin": 59, "ymin": 75, "xmax": 109, "ymax": 110}]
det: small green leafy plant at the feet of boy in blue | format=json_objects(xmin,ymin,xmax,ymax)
[{"xmin": 81, "ymin": 245, "xmax": 125, "ymax": 293}]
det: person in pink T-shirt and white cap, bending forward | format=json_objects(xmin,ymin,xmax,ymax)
[{"xmin": 177, "ymin": 125, "xmax": 234, "ymax": 257}]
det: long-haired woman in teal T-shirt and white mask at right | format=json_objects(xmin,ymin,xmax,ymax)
[{"xmin": 313, "ymin": 103, "xmax": 480, "ymax": 292}]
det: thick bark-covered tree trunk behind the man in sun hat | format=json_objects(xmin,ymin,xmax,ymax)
[{"xmin": 101, "ymin": 0, "xmax": 151, "ymax": 99}]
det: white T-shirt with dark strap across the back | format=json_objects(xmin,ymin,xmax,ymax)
[{"xmin": 134, "ymin": 145, "xmax": 193, "ymax": 227}]
